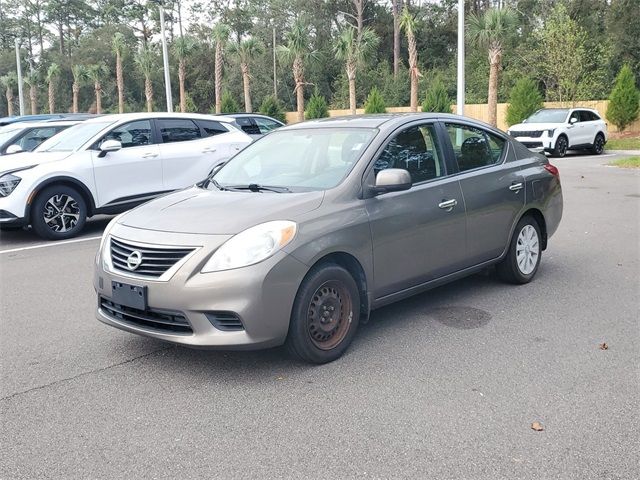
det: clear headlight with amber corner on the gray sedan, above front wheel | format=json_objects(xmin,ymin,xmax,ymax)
[{"xmin": 202, "ymin": 220, "xmax": 297, "ymax": 273}]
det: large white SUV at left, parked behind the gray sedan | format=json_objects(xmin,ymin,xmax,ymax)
[{"xmin": 0, "ymin": 113, "xmax": 252, "ymax": 240}]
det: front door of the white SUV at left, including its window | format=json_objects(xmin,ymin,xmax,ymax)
[{"xmin": 92, "ymin": 120, "xmax": 164, "ymax": 208}]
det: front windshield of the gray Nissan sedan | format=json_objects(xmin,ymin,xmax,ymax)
[{"xmin": 207, "ymin": 128, "xmax": 378, "ymax": 191}]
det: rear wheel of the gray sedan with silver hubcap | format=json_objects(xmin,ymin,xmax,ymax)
[{"xmin": 496, "ymin": 215, "xmax": 542, "ymax": 284}]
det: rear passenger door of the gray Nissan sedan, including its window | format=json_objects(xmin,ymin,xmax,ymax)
[{"xmin": 444, "ymin": 122, "xmax": 525, "ymax": 266}]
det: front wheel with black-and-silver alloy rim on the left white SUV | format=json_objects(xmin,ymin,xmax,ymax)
[{"xmin": 31, "ymin": 185, "xmax": 87, "ymax": 240}]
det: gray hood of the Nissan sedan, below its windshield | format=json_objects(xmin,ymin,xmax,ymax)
[{"xmin": 118, "ymin": 187, "xmax": 324, "ymax": 235}]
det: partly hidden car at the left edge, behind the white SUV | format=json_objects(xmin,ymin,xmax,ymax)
[{"xmin": 0, "ymin": 120, "xmax": 80, "ymax": 156}]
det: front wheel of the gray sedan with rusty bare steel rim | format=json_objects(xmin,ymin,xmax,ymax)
[{"xmin": 285, "ymin": 263, "xmax": 360, "ymax": 364}]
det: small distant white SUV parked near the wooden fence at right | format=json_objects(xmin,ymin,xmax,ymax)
[{"xmin": 508, "ymin": 108, "xmax": 607, "ymax": 157}]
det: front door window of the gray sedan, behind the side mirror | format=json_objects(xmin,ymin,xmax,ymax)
[{"xmin": 374, "ymin": 125, "xmax": 445, "ymax": 183}]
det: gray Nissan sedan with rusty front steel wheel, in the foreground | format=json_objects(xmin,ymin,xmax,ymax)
[{"xmin": 94, "ymin": 114, "xmax": 562, "ymax": 363}]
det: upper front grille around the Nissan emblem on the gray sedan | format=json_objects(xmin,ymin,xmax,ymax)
[{"xmin": 111, "ymin": 237, "xmax": 193, "ymax": 278}]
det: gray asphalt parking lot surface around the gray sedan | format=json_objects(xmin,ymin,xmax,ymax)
[{"xmin": 0, "ymin": 151, "xmax": 640, "ymax": 479}]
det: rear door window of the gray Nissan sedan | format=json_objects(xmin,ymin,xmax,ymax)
[{"xmin": 445, "ymin": 123, "xmax": 506, "ymax": 172}]
